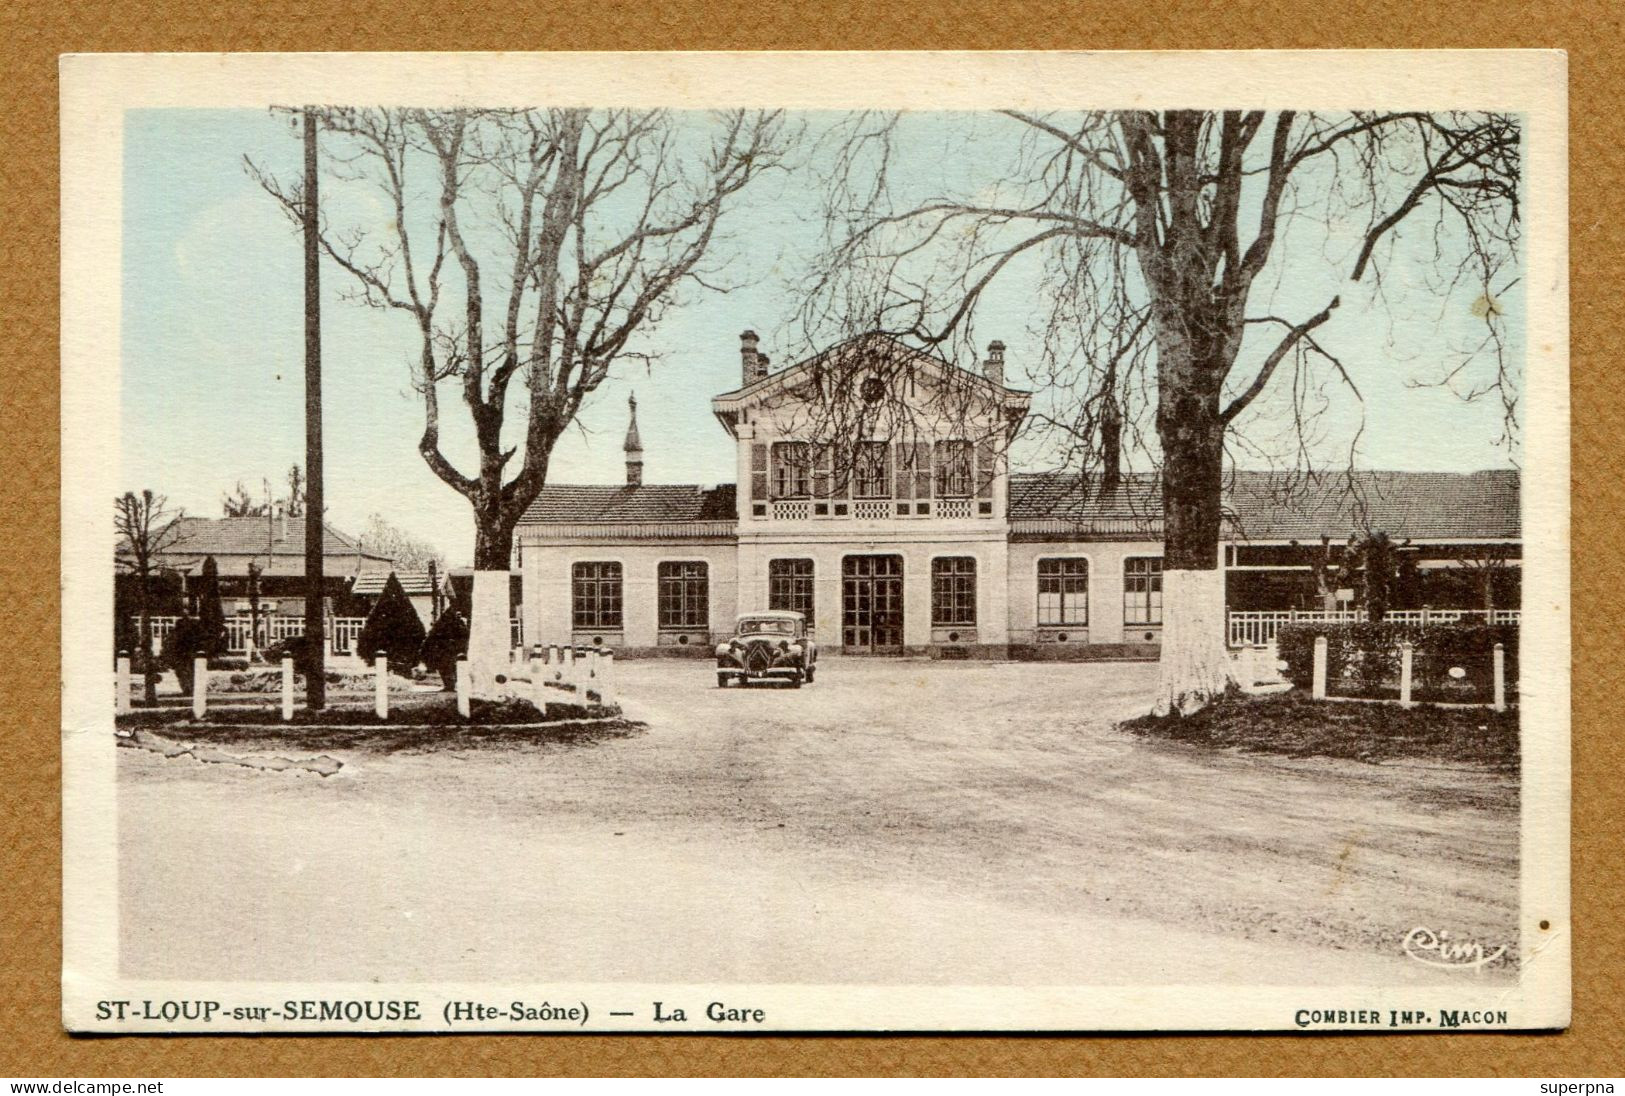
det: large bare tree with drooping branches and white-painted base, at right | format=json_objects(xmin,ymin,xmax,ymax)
[{"xmin": 813, "ymin": 111, "xmax": 1519, "ymax": 712}]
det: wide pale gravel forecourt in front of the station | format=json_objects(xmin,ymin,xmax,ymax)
[{"xmin": 119, "ymin": 657, "xmax": 1518, "ymax": 985}]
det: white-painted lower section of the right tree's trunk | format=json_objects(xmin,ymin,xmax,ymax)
[{"xmin": 1152, "ymin": 568, "xmax": 1235, "ymax": 715}]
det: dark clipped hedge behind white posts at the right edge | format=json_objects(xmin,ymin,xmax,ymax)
[{"xmin": 1276, "ymin": 621, "xmax": 1518, "ymax": 699}]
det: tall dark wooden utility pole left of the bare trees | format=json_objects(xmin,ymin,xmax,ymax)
[{"xmin": 302, "ymin": 107, "xmax": 327, "ymax": 712}]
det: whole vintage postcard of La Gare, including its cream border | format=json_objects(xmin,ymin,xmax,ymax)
[{"xmin": 62, "ymin": 52, "xmax": 1570, "ymax": 1033}]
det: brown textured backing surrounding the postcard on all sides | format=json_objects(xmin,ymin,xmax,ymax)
[{"xmin": 0, "ymin": 0, "xmax": 1625, "ymax": 1078}]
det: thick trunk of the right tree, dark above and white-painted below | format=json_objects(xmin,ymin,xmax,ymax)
[{"xmin": 1152, "ymin": 349, "xmax": 1235, "ymax": 715}]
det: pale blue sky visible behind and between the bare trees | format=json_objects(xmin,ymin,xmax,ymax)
[{"xmin": 119, "ymin": 109, "xmax": 1523, "ymax": 563}]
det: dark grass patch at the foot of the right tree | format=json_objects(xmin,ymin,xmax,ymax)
[{"xmin": 1121, "ymin": 689, "xmax": 1518, "ymax": 776}]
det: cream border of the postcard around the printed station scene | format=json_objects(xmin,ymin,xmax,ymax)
[{"xmin": 62, "ymin": 50, "xmax": 1570, "ymax": 1031}]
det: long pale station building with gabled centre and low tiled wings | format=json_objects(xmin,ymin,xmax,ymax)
[{"xmin": 515, "ymin": 332, "xmax": 1521, "ymax": 659}]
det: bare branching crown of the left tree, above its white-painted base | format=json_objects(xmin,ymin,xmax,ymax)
[{"xmin": 249, "ymin": 107, "xmax": 783, "ymax": 571}]
